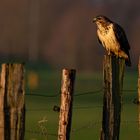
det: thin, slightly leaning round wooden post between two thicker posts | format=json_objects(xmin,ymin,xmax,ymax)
[{"xmin": 58, "ymin": 69, "xmax": 76, "ymax": 140}]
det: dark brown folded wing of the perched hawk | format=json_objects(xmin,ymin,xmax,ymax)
[{"xmin": 113, "ymin": 23, "xmax": 130, "ymax": 51}]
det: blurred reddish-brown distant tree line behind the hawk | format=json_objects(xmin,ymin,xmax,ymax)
[{"xmin": 0, "ymin": 0, "xmax": 140, "ymax": 70}]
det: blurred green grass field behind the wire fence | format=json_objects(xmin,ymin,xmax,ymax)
[{"xmin": 25, "ymin": 70, "xmax": 140, "ymax": 140}]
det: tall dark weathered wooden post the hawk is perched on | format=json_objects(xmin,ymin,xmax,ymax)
[{"xmin": 100, "ymin": 55, "xmax": 125, "ymax": 140}]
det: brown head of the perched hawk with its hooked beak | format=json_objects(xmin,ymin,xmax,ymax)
[{"xmin": 93, "ymin": 15, "xmax": 112, "ymax": 26}]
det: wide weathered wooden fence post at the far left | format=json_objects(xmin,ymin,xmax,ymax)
[{"xmin": 0, "ymin": 64, "xmax": 25, "ymax": 140}]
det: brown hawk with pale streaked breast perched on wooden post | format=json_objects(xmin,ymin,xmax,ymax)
[{"xmin": 93, "ymin": 15, "xmax": 131, "ymax": 66}]
